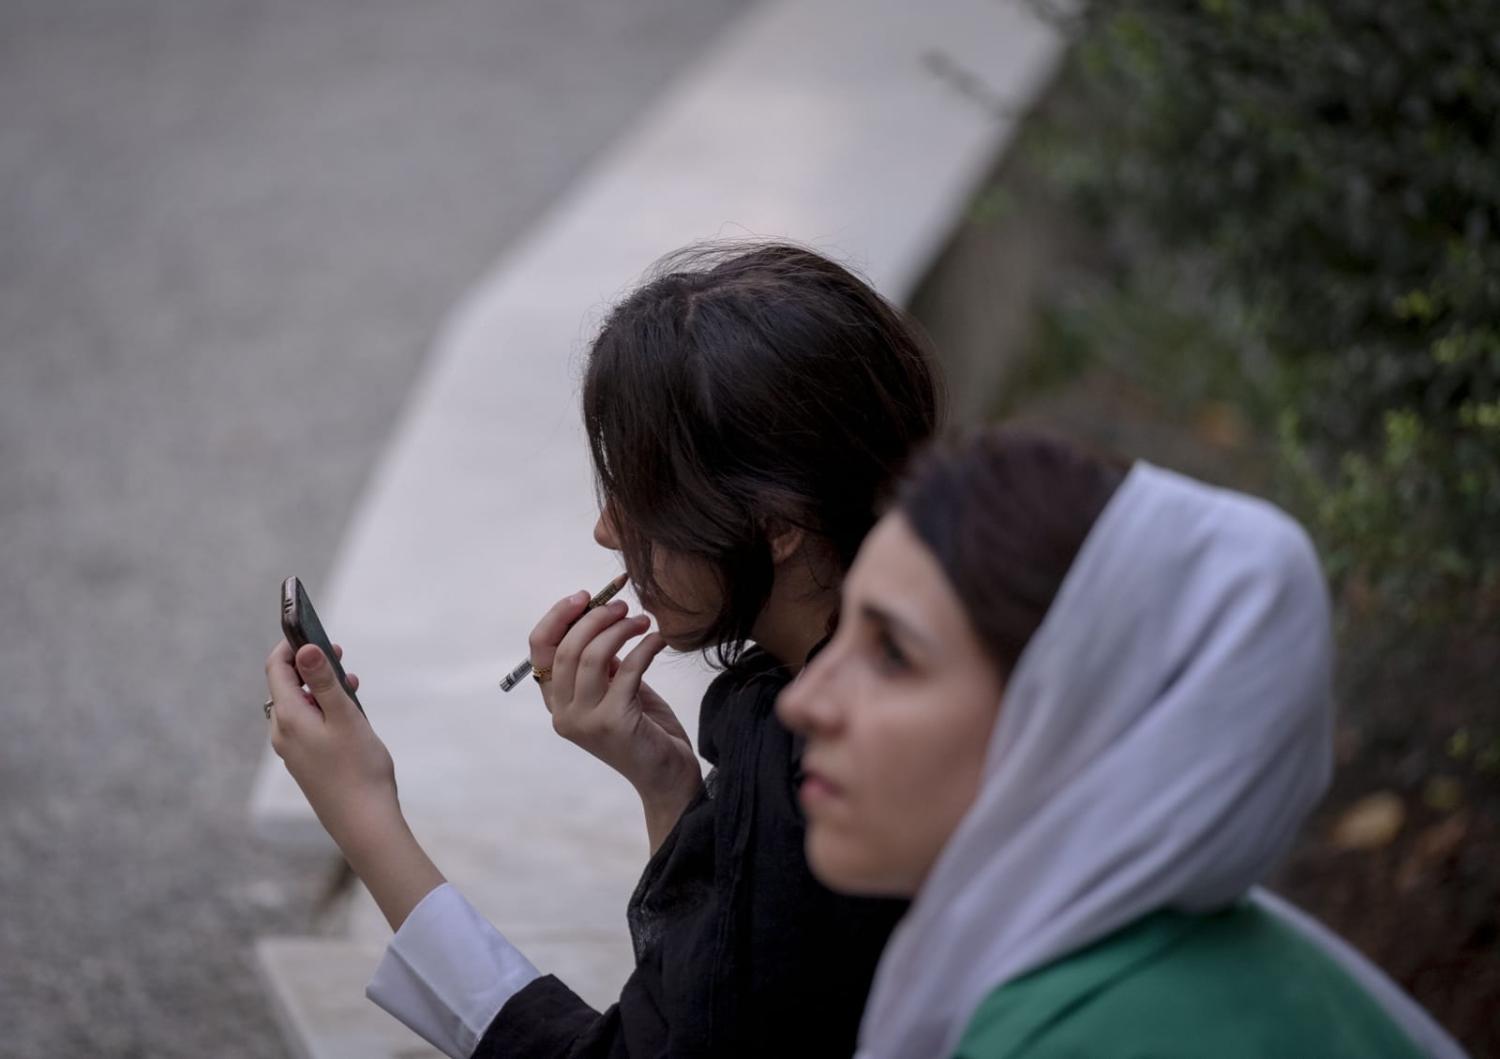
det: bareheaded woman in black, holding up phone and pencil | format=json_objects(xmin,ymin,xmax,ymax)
[{"xmin": 267, "ymin": 245, "xmax": 939, "ymax": 1058}]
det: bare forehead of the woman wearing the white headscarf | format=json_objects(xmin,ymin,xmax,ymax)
[{"xmin": 845, "ymin": 512, "xmax": 969, "ymax": 644}]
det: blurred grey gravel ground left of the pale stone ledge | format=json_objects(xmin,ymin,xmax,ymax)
[{"xmin": 0, "ymin": 0, "xmax": 744, "ymax": 1058}]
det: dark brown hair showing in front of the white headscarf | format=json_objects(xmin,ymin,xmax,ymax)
[{"xmin": 896, "ymin": 428, "xmax": 1125, "ymax": 675}]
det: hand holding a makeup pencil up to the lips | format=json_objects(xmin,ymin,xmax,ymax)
[{"xmin": 531, "ymin": 593, "xmax": 704, "ymax": 849}]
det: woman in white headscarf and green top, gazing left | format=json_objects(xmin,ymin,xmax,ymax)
[{"xmin": 779, "ymin": 431, "xmax": 1463, "ymax": 1059}]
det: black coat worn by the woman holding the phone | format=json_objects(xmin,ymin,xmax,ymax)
[{"xmin": 474, "ymin": 650, "xmax": 906, "ymax": 1059}]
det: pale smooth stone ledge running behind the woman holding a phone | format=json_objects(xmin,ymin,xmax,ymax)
[{"xmin": 246, "ymin": 0, "xmax": 1059, "ymax": 1056}]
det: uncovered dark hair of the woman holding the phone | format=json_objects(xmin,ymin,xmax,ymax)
[{"xmin": 584, "ymin": 245, "xmax": 941, "ymax": 666}]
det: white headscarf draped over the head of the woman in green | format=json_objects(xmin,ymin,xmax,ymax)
[{"xmin": 858, "ymin": 464, "xmax": 1463, "ymax": 1059}]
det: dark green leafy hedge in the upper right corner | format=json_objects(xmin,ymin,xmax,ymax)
[{"xmin": 1053, "ymin": 0, "xmax": 1500, "ymax": 615}]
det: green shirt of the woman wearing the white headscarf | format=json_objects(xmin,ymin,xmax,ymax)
[{"xmin": 954, "ymin": 905, "xmax": 1422, "ymax": 1059}]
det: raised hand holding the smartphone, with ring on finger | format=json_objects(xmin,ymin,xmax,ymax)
[{"xmin": 266, "ymin": 641, "xmax": 405, "ymax": 855}]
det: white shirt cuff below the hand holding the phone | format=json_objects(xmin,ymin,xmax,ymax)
[{"xmin": 365, "ymin": 884, "xmax": 542, "ymax": 1059}]
